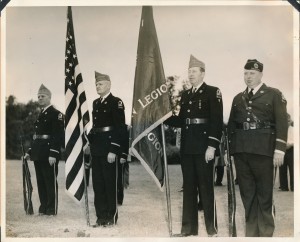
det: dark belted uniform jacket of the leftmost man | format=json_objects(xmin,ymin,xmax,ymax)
[{"xmin": 28, "ymin": 106, "xmax": 65, "ymax": 160}]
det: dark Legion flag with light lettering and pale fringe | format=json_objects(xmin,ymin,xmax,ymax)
[{"xmin": 131, "ymin": 6, "xmax": 172, "ymax": 190}]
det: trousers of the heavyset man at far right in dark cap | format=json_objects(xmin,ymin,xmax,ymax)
[{"xmin": 234, "ymin": 153, "xmax": 275, "ymax": 237}]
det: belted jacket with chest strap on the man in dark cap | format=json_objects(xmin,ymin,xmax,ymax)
[{"xmin": 228, "ymin": 84, "xmax": 288, "ymax": 157}]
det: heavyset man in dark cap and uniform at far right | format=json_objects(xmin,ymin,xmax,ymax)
[{"xmin": 228, "ymin": 59, "xmax": 287, "ymax": 237}]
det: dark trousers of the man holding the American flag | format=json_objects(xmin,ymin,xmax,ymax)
[{"xmin": 92, "ymin": 155, "xmax": 118, "ymax": 224}]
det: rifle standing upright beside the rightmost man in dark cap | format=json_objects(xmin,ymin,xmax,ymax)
[{"xmin": 225, "ymin": 128, "xmax": 237, "ymax": 237}]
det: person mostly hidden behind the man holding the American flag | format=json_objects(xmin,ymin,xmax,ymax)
[{"xmin": 117, "ymin": 126, "xmax": 129, "ymax": 205}]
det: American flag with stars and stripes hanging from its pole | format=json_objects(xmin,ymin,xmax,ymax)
[{"xmin": 65, "ymin": 7, "xmax": 90, "ymax": 202}]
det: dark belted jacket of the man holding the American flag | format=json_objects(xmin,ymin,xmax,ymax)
[{"xmin": 88, "ymin": 94, "xmax": 125, "ymax": 156}]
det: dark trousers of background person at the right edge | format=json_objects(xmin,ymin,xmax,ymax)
[{"xmin": 279, "ymin": 147, "xmax": 294, "ymax": 191}]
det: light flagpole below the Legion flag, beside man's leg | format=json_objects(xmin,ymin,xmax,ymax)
[{"xmin": 161, "ymin": 123, "xmax": 173, "ymax": 237}]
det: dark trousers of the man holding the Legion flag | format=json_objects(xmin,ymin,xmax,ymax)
[{"xmin": 181, "ymin": 154, "xmax": 218, "ymax": 235}]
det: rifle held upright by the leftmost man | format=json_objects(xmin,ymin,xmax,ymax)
[{"xmin": 21, "ymin": 136, "xmax": 33, "ymax": 215}]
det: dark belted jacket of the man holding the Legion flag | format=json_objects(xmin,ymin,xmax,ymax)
[{"xmin": 166, "ymin": 83, "xmax": 223, "ymax": 154}]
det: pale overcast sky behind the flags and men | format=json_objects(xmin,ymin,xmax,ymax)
[{"xmin": 5, "ymin": 4, "xmax": 298, "ymax": 124}]
